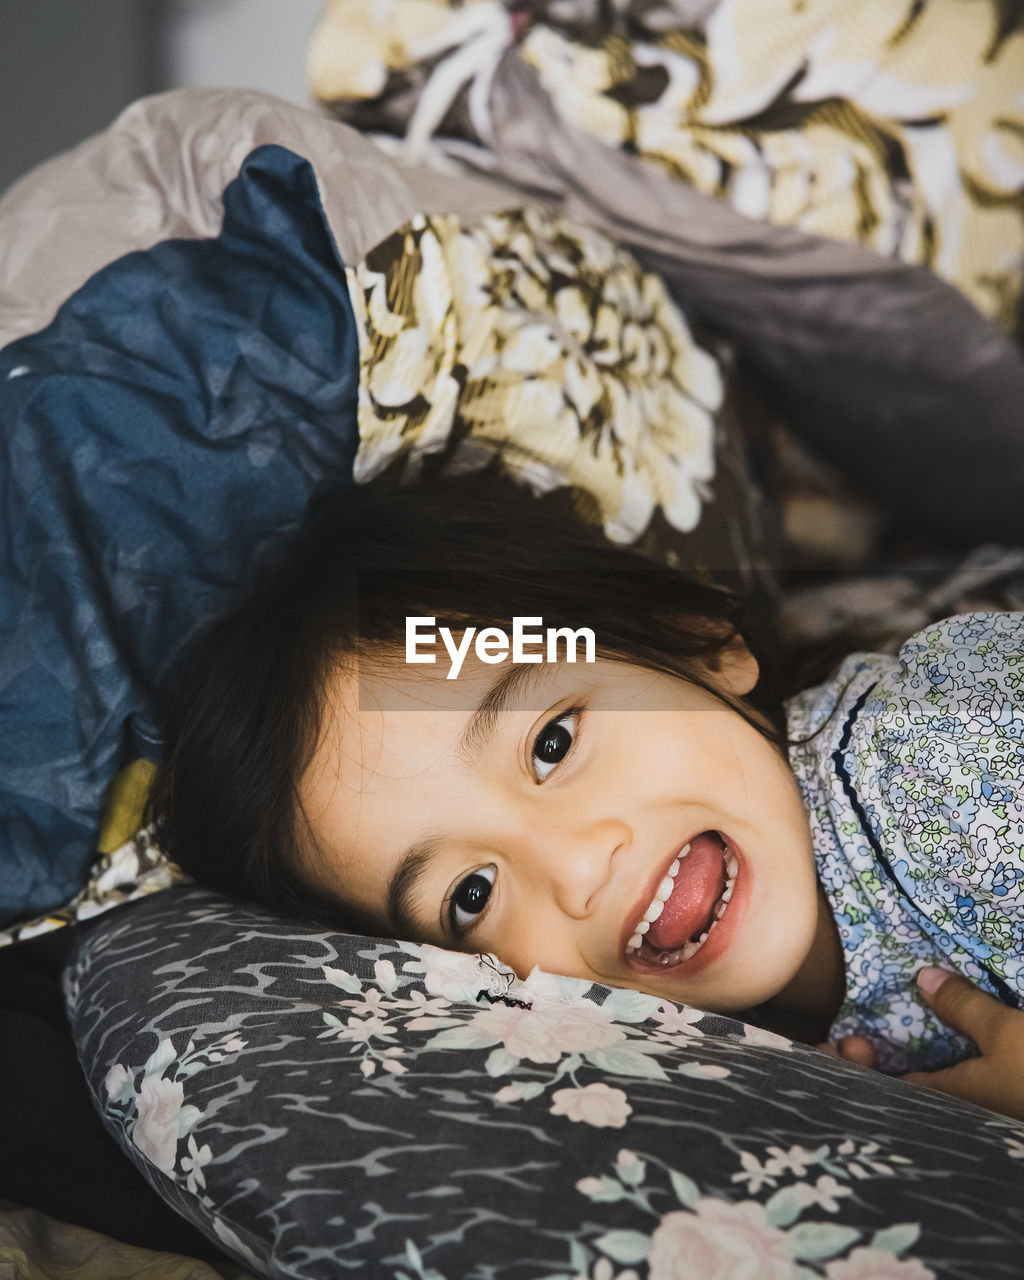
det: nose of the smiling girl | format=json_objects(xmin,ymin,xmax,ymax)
[{"xmin": 513, "ymin": 813, "xmax": 630, "ymax": 920}]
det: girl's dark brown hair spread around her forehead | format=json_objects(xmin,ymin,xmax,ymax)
[{"xmin": 148, "ymin": 466, "xmax": 782, "ymax": 925}]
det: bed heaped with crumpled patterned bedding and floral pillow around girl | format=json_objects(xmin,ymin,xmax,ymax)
[{"xmin": 0, "ymin": 0, "xmax": 1024, "ymax": 1280}]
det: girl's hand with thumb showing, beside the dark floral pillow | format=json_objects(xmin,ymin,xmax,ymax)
[{"xmin": 818, "ymin": 969, "xmax": 1024, "ymax": 1120}]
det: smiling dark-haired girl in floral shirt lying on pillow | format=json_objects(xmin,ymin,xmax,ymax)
[{"xmin": 150, "ymin": 471, "xmax": 1024, "ymax": 1111}]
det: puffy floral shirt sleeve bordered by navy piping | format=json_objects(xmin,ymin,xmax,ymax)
[{"xmin": 851, "ymin": 613, "xmax": 1024, "ymax": 1002}]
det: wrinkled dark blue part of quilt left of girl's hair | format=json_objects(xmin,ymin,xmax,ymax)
[{"xmin": 0, "ymin": 146, "xmax": 358, "ymax": 924}]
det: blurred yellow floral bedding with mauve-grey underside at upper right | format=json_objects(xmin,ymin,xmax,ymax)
[{"xmin": 308, "ymin": 0, "xmax": 1024, "ymax": 547}]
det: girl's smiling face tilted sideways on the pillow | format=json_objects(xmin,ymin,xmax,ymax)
[{"xmin": 301, "ymin": 645, "xmax": 818, "ymax": 1012}]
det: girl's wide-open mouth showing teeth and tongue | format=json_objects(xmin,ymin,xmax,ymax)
[{"xmin": 626, "ymin": 831, "xmax": 740, "ymax": 968}]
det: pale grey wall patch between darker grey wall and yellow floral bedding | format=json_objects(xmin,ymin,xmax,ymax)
[{"xmin": 164, "ymin": 0, "xmax": 323, "ymax": 106}]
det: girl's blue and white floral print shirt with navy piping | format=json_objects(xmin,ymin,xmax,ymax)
[{"xmin": 787, "ymin": 613, "xmax": 1024, "ymax": 1073}]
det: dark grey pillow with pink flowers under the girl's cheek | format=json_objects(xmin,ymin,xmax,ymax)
[{"xmin": 65, "ymin": 886, "xmax": 1024, "ymax": 1280}]
